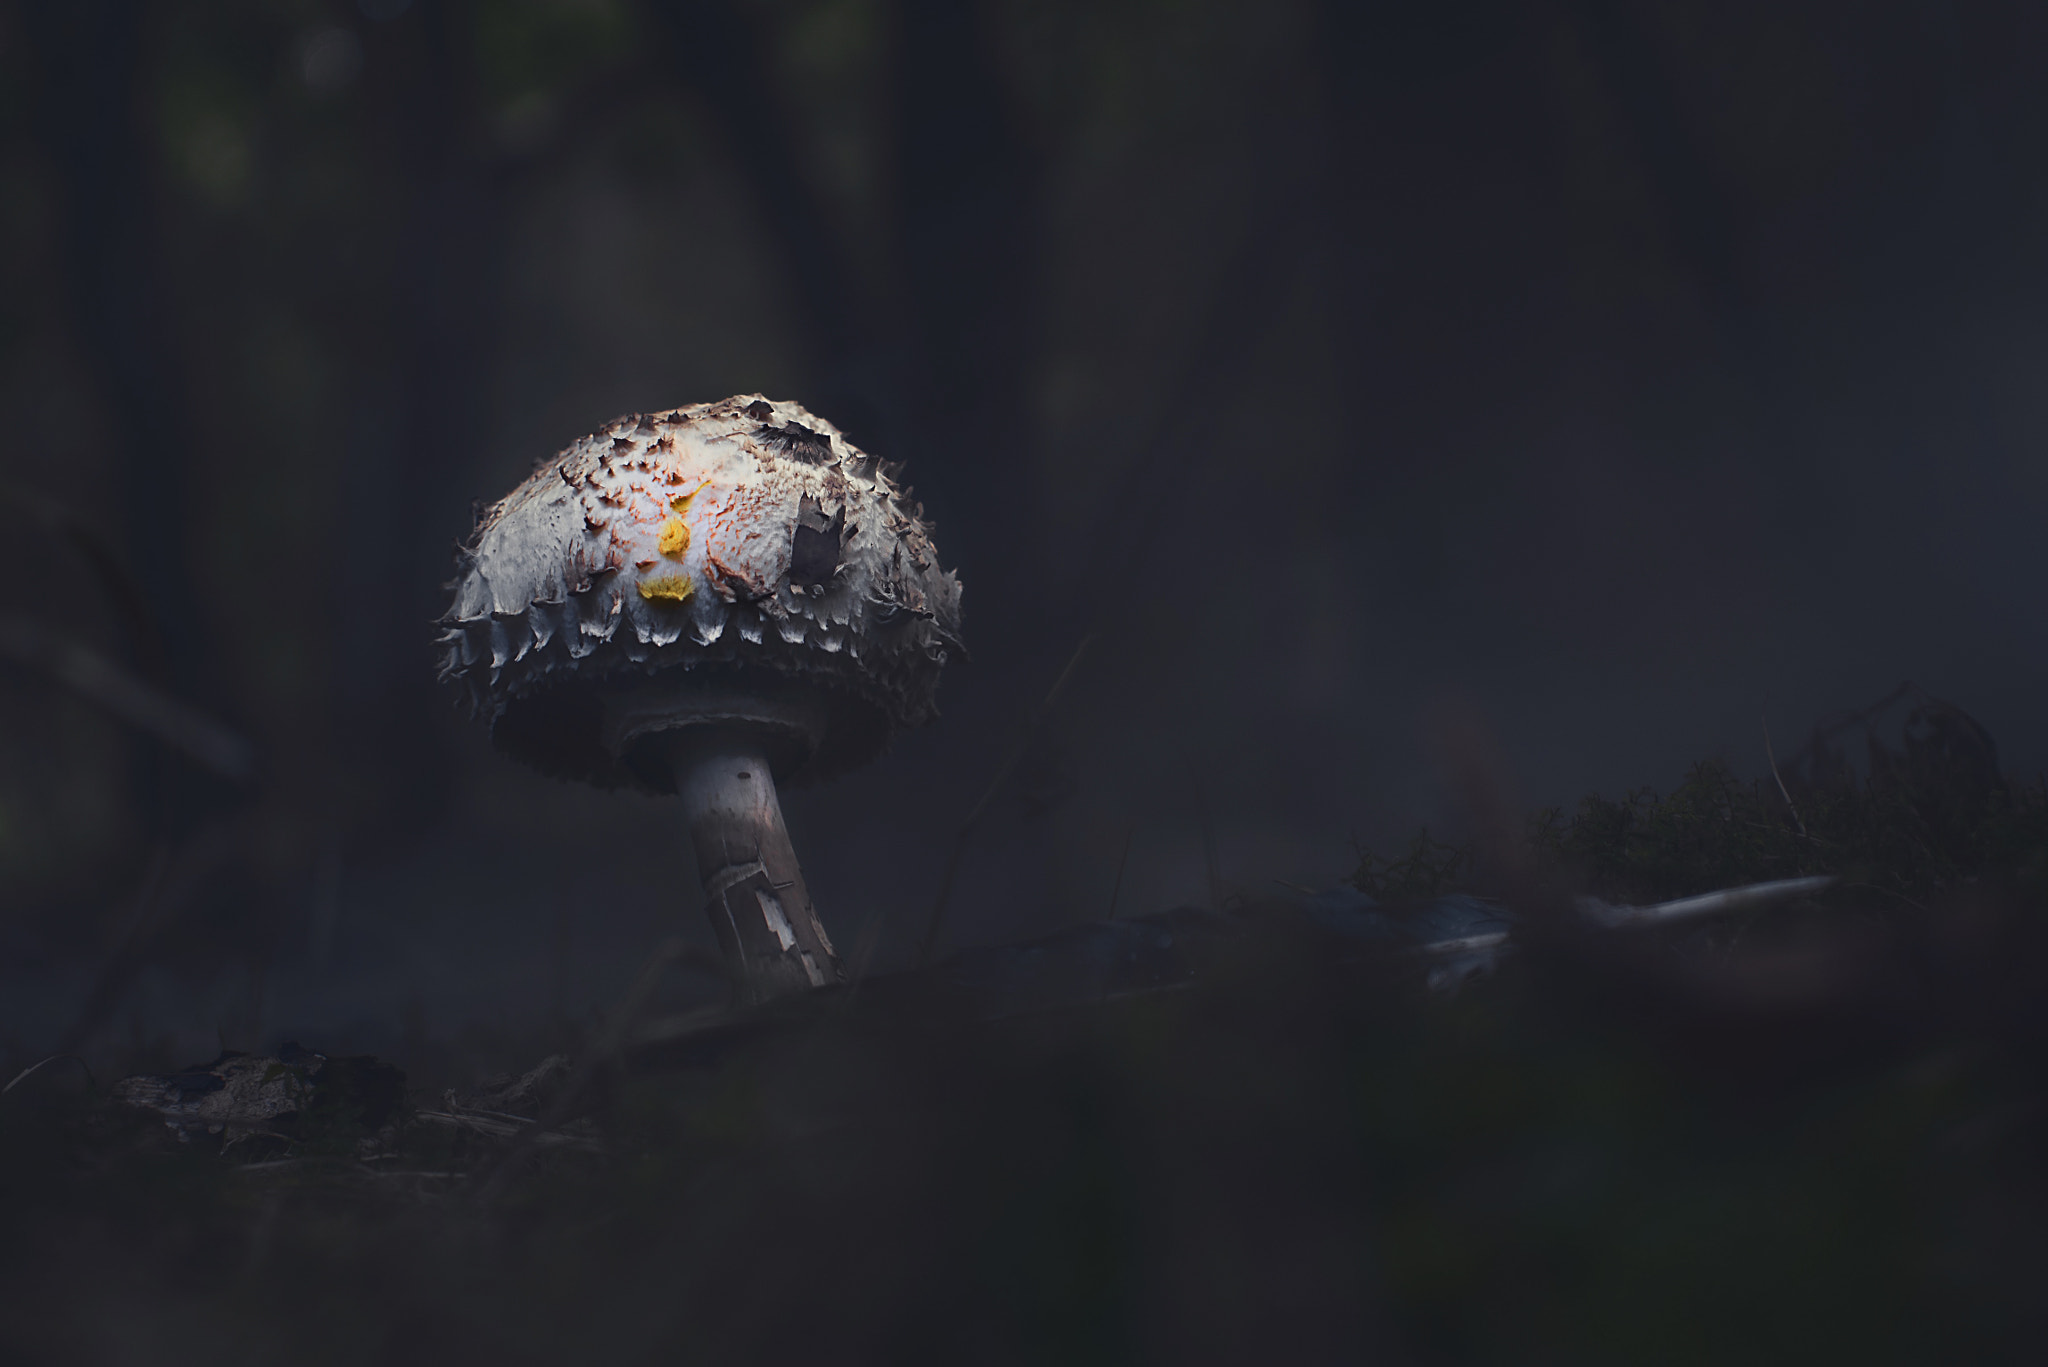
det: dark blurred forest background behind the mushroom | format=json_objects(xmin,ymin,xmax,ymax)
[{"xmin": 0, "ymin": 0, "xmax": 2048, "ymax": 1076}]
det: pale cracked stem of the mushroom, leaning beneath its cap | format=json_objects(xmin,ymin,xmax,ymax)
[{"xmin": 657, "ymin": 726, "xmax": 846, "ymax": 1002}]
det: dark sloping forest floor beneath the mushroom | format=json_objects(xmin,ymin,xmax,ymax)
[{"xmin": 0, "ymin": 701, "xmax": 2048, "ymax": 1363}]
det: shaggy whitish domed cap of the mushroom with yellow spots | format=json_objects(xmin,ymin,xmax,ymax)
[{"xmin": 440, "ymin": 393, "xmax": 961, "ymax": 789}]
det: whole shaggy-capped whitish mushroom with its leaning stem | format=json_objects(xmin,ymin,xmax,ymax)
[{"xmin": 440, "ymin": 393, "xmax": 961, "ymax": 1000}]
